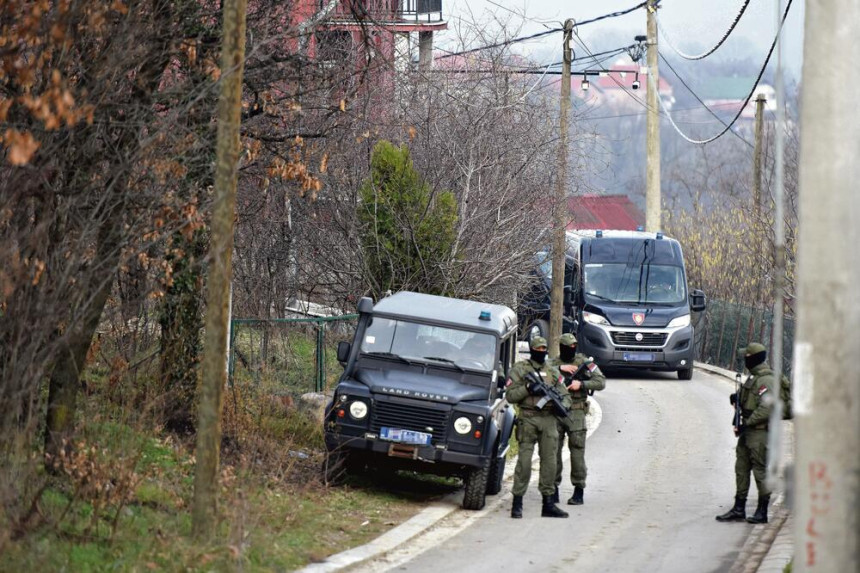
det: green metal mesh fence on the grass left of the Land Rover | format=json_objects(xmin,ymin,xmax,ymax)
[{"xmin": 227, "ymin": 314, "xmax": 358, "ymax": 397}]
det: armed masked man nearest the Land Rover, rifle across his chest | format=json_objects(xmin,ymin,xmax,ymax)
[{"xmin": 505, "ymin": 336, "xmax": 570, "ymax": 518}]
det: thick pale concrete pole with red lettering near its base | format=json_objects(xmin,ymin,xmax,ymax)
[{"xmin": 792, "ymin": 0, "xmax": 860, "ymax": 573}]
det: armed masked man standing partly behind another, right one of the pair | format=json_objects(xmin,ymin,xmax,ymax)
[{"xmin": 550, "ymin": 332, "xmax": 606, "ymax": 505}]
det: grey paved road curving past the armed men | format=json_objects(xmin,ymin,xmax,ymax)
[{"xmin": 358, "ymin": 370, "xmax": 755, "ymax": 573}]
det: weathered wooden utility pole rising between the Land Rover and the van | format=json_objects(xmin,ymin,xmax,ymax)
[{"xmin": 547, "ymin": 18, "xmax": 573, "ymax": 358}]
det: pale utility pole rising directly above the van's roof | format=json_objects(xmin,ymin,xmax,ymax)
[{"xmin": 645, "ymin": 0, "xmax": 661, "ymax": 232}]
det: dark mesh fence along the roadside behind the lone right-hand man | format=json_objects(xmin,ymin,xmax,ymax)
[{"xmin": 695, "ymin": 300, "xmax": 795, "ymax": 375}]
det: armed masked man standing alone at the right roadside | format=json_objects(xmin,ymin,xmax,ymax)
[{"xmin": 717, "ymin": 342, "xmax": 774, "ymax": 523}]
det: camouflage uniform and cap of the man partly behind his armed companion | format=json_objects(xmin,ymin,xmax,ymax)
[{"xmin": 551, "ymin": 333, "xmax": 606, "ymax": 505}]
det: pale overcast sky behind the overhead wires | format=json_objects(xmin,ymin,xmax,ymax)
[{"xmin": 435, "ymin": 0, "xmax": 804, "ymax": 79}]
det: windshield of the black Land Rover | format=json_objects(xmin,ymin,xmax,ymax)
[{"xmin": 361, "ymin": 317, "xmax": 496, "ymax": 371}]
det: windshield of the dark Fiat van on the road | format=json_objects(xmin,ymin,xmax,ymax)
[{"xmin": 583, "ymin": 263, "xmax": 687, "ymax": 306}]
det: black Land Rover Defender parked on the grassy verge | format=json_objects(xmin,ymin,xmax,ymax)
[{"xmin": 323, "ymin": 292, "xmax": 517, "ymax": 509}]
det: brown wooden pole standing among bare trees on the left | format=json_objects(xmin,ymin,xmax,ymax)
[{"xmin": 191, "ymin": 0, "xmax": 247, "ymax": 541}]
